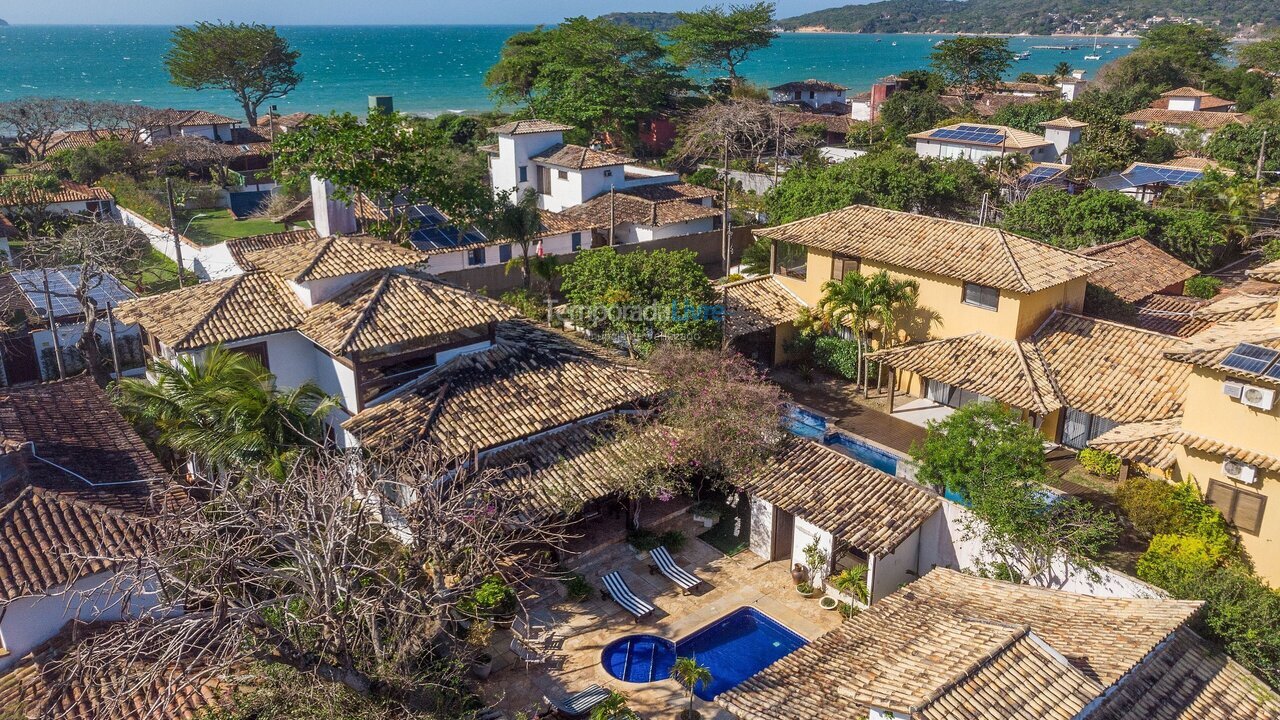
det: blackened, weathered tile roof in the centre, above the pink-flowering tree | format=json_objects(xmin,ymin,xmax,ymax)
[{"xmin": 343, "ymin": 320, "xmax": 658, "ymax": 455}]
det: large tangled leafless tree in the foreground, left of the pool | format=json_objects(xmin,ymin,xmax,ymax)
[{"xmin": 42, "ymin": 445, "xmax": 564, "ymax": 716}]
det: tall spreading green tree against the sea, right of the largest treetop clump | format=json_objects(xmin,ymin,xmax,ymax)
[{"xmin": 667, "ymin": 3, "xmax": 777, "ymax": 86}]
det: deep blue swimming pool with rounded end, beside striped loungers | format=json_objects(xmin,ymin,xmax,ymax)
[{"xmin": 600, "ymin": 607, "xmax": 808, "ymax": 701}]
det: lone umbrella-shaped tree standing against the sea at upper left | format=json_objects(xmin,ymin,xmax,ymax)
[{"xmin": 164, "ymin": 22, "xmax": 302, "ymax": 127}]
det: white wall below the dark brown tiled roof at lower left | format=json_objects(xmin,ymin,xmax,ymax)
[{"xmin": 0, "ymin": 573, "xmax": 170, "ymax": 673}]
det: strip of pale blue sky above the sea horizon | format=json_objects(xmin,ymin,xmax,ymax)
[{"xmin": 0, "ymin": 0, "xmax": 850, "ymax": 24}]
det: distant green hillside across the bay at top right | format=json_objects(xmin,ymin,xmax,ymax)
[{"xmin": 778, "ymin": 0, "xmax": 1280, "ymax": 35}]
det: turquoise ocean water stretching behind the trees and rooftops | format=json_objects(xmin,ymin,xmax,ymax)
[{"xmin": 0, "ymin": 26, "xmax": 1133, "ymax": 117}]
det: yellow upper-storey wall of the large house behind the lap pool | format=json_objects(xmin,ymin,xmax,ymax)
[{"xmin": 778, "ymin": 249, "xmax": 1085, "ymax": 341}]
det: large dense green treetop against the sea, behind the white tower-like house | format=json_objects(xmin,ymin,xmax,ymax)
[{"xmin": 485, "ymin": 17, "xmax": 692, "ymax": 141}]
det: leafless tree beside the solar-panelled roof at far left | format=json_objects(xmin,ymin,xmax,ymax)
[{"xmin": 27, "ymin": 222, "xmax": 151, "ymax": 386}]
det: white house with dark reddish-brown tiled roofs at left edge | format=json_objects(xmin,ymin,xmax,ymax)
[{"xmin": 0, "ymin": 375, "xmax": 168, "ymax": 673}]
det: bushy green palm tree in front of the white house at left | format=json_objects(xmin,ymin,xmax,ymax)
[{"xmin": 116, "ymin": 346, "xmax": 337, "ymax": 478}]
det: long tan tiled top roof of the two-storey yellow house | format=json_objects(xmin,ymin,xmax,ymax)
[{"xmin": 755, "ymin": 205, "xmax": 1107, "ymax": 292}]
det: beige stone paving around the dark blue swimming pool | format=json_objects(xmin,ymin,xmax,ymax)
[{"xmin": 483, "ymin": 514, "xmax": 841, "ymax": 719}]
